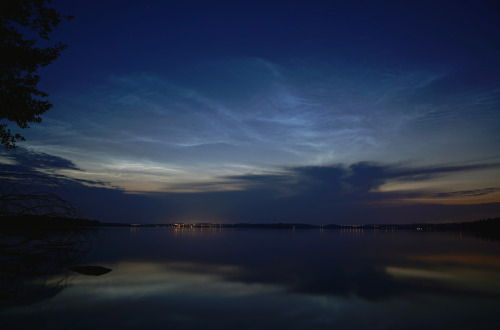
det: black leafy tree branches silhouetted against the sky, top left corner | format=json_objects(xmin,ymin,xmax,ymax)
[{"xmin": 0, "ymin": 0, "xmax": 72, "ymax": 148}]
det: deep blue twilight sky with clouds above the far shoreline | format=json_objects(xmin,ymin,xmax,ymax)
[{"xmin": 0, "ymin": 0, "xmax": 500, "ymax": 224}]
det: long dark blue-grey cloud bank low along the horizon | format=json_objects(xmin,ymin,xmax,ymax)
[{"xmin": 2, "ymin": 149, "xmax": 500, "ymax": 223}]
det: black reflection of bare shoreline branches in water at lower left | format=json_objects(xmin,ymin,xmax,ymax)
[{"xmin": 0, "ymin": 228, "xmax": 96, "ymax": 310}]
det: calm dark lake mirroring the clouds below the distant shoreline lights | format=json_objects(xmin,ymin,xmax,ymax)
[{"xmin": 0, "ymin": 228, "xmax": 500, "ymax": 330}]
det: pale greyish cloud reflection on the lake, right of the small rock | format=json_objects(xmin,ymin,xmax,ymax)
[{"xmin": 66, "ymin": 261, "xmax": 284, "ymax": 299}]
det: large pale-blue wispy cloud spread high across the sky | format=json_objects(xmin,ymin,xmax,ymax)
[{"xmin": 18, "ymin": 58, "xmax": 500, "ymax": 196}]
